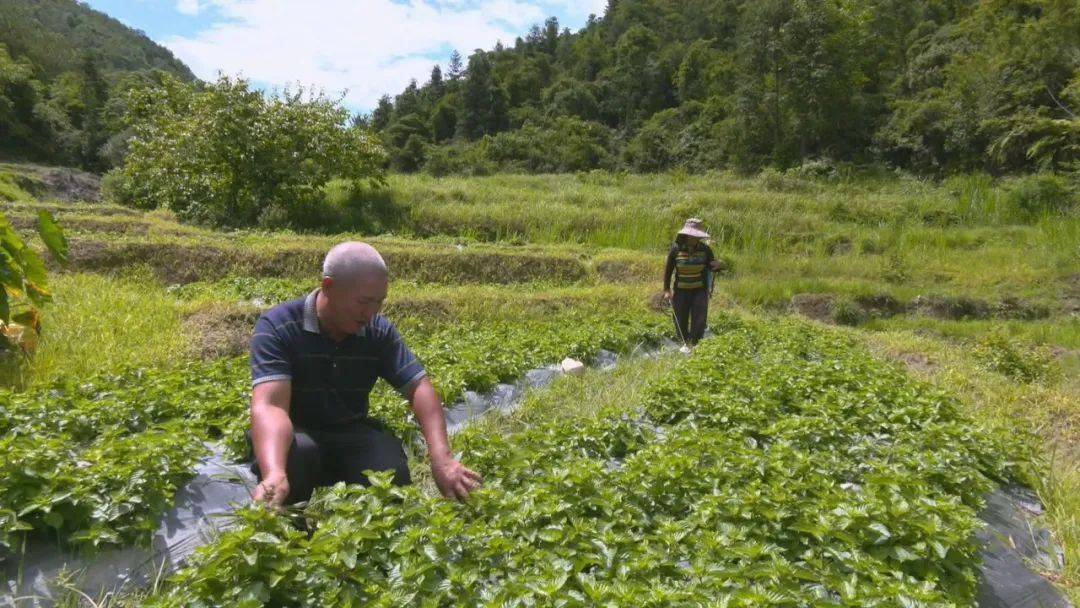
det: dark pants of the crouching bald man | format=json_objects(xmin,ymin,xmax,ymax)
[{"xmin": 247, "ymin": 422, "xmax": 411, "ymax": 504}]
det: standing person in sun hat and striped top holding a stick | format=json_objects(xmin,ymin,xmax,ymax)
[{"xmin": 664, "ymin": 217, "xmax": 720, "ymax": 351}]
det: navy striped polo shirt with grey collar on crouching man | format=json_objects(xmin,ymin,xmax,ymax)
[{"xmin": 252, "ymin": 289, "xmax": 424, "ymax": 430}]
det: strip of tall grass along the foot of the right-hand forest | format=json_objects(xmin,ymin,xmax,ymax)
[{"xmin": 389, "ymin": 174, "xmax": 1064, "ymax": 251}]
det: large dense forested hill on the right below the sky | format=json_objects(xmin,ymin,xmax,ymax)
[{"xmin": 367, "ymin": 0, "xmax": 1080, "ymax": 174}]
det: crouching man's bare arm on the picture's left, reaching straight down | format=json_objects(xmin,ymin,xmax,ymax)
[{"xmin": 252, "ymin": 380, "xmax": 293, "ymax": 504}]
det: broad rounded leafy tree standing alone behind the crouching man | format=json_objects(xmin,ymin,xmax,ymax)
[{"xmin": 106, "ymin": 77, "xmax": 388, "ymax": 231}]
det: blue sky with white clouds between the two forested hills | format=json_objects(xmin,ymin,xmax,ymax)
[{"xmin": 85, "ymin": 0, "xmax": 607, "ymax": 111}]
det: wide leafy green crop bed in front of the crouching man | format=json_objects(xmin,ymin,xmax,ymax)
[{"xmin": 149, "ymin": 321, "xmax": 1032, "ymax": 607}]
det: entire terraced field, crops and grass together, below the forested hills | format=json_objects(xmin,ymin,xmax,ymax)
[{"xmin": 0, "ymin": 164, "xmax": 1080, "ymax": 606}]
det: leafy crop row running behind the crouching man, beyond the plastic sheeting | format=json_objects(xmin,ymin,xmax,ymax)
[{"xmin": 0, "ymin": 310, "xmax": 666, "ymax": 555}]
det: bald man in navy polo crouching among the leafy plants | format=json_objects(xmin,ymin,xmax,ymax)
[{"xmin": 251, "ymin": 242, "xmax": 481, "ymax": 504}]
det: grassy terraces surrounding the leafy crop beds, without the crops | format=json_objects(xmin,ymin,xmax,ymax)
[{"xmin": 0, "ymin": 167, "xmax": 1080, "ymax": 602}]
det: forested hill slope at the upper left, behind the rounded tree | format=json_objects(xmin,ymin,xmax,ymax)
[{"xmin": 0, "ymin": 0, "xmax": 194, "ymax": 170}]
